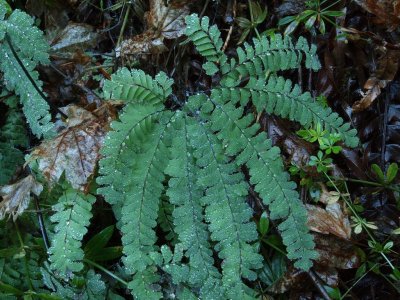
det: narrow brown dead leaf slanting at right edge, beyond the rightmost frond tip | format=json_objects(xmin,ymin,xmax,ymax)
[{"xmin": 353, "ymin": 50, "xmax": 400, "ymax": 111}]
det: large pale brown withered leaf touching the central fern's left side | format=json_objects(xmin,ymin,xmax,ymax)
[{"xmin": 31, "ymin": 105, "xmax": 112, "ymax": 190}]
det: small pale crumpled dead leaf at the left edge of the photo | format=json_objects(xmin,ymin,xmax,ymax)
[{"xmin": 0, "ymin": 175, "xmax": 43, "ymax": 221}]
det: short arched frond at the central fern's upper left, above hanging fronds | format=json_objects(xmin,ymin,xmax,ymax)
[{"xmin": 103, "ymin": 68, "xmax": 173, "ymax": 104}]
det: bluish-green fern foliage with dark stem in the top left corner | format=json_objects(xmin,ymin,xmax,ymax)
[{"xmin": 0, "ymin": 2, "xmax": 53, "ymax": 138}]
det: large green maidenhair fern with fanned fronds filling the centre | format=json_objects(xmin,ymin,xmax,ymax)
[{"xmin": 98, "ymin": 15, "xmax": 358, "ymax": 299}]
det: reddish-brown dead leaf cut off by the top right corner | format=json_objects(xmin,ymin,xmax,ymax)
[{"xmin": 355, "ymin": 0, "xmax": 400, "ymax": 30}]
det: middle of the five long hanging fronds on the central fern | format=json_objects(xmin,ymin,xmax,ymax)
[{"xmin": 166, "ymin": 117, "xmax": 224, "ymax": 299}]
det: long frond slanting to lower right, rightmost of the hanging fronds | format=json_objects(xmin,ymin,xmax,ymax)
[{"xmin": 194, "ymin": 93, "xmax": 316, "ymax": 270}]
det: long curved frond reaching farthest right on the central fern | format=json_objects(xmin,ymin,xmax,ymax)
[{"xmin": 211, "ymin": 76, "xmax": 358, "ymax": 147}]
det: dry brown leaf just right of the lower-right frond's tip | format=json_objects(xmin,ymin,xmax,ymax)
[{"xmin": 306, "ymin": 203, "xmax": 351, "ymax": 240}]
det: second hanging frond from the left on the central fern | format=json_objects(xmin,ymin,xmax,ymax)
[{"xmin": 121, "ymin": 113, "xmax": 173, "ymax": 299}]
